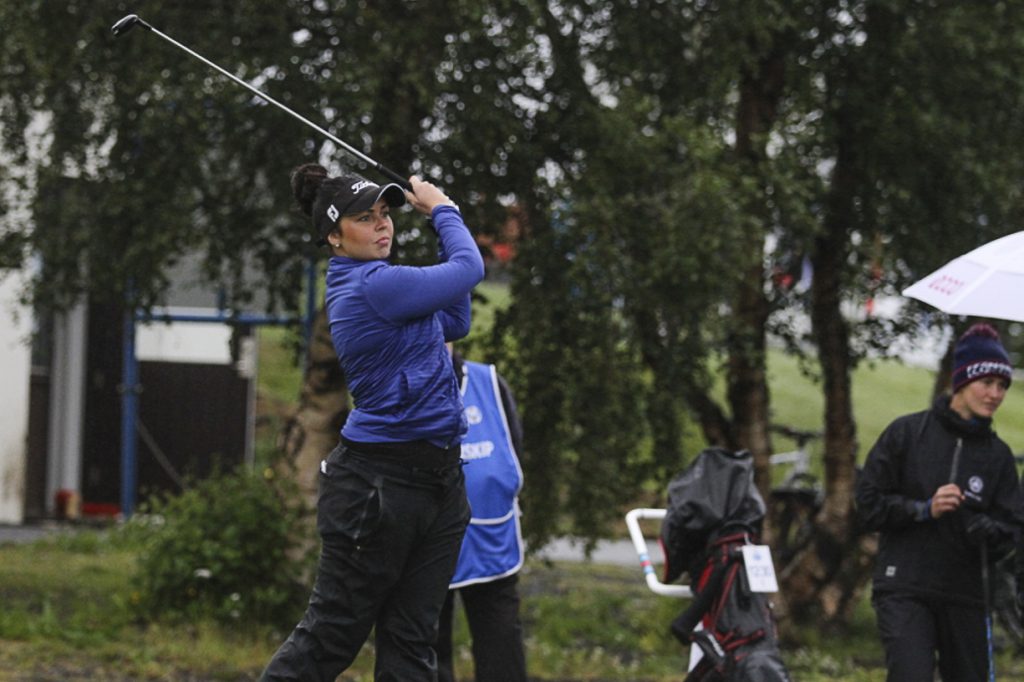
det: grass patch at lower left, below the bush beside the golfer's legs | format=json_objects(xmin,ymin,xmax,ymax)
[{"xmin": 0, "ymin": 528, "xmax": 292, "ymax": 680}]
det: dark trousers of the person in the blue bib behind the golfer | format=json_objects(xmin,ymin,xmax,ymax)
[{"xmin": 437, "ymin": 574, "xmax": 526, "ymax": 682}]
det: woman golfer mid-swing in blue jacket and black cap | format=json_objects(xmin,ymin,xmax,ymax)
[{"xmin": 262, "ymin": 164, "xmax": 483, "ymax": 682}]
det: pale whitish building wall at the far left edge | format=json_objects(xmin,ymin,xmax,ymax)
[{"xmin": 0, "ymin": 270, "xmax": 32, "ymax": 523}]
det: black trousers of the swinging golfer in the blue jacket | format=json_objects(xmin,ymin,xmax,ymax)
[{"xmin": 261, "ymin": 445, "xmax": 469, "ymax": 682}]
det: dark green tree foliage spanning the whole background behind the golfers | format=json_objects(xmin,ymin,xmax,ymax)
[{"xmin": 6, "ymin": 0, "xmax": 1024, "ymax": 626}]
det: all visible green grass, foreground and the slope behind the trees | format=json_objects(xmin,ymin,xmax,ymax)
[{"xmin": 6, "ymin": 283, "xmax": 1007, "ymax": 682}]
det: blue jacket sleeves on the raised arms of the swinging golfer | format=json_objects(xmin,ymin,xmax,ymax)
[{"xmin": 366, "ymin": 206, "xmax": 483, "ymax": 331}]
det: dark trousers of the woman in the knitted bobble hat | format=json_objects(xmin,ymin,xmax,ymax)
[{"xmin": 871, "ymin": 594, "xmax": 988, "ymax": 682}]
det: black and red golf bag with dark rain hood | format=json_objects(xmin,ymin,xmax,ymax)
[{"xmin": 659, "ymin": 447, "xmax": 790, "ymax": 682}]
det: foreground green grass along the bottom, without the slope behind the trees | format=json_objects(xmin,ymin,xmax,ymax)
[{"xmin": 0, "ymin": 529, "xmax": 1024, "ymax": 682}]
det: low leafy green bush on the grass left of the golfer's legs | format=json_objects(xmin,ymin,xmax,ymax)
[{"xmin": 130, "ymin": 468, "xmax": 310, "ymax": 626}]
